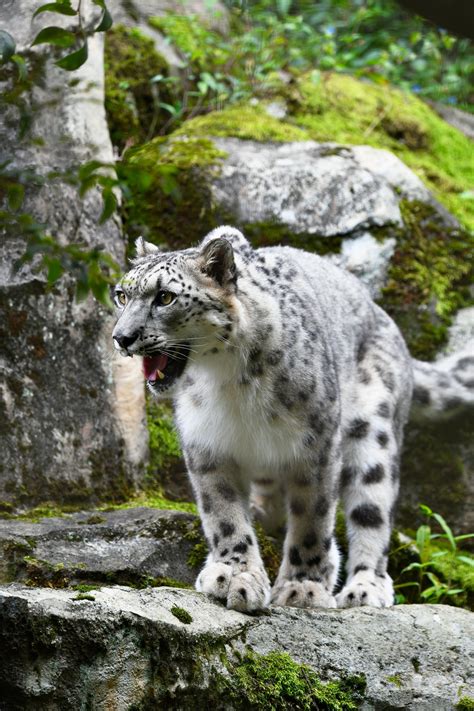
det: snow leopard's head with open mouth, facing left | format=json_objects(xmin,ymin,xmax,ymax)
[{"xmin": 112, "ymin": 227, "xmax": 244, "ymax": 395}]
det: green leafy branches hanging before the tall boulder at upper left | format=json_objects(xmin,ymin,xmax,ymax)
[{"xmin": 0, "ymin": 0, "xmax": 119, "ymax": 305}]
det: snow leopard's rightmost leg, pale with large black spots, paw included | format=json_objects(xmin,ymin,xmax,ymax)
[{"xmin": 336, "ymin": 338, "xmax": 412, "ymax": 607}]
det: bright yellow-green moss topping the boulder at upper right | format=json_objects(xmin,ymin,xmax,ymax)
[{"xmin": 288, "ymin": 72, "xmax": 474, "ymax": 229}]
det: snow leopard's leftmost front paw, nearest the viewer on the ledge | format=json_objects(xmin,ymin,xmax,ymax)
[{"xmin": 196, "ymin": 563, "xmax": 270, "ymax": 612}]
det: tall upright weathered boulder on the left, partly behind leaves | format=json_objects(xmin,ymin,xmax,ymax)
[{"xmin": 0, "ymin": 0, "xmax": 147, "ymax": 505}]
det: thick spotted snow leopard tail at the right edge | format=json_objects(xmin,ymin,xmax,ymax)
[{"xmin": 412, "ymin": 343, "xmax": 474, "ymax": 419}]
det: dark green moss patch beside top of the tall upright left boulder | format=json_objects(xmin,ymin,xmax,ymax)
[{"xmin": 105, "ymin": 25, "xmax": 173, "ymax": 148}]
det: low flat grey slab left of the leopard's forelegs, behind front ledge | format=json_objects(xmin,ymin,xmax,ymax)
[{"xmin": 0, "ymin": 507, "xmax": 200, "ymax": 585}]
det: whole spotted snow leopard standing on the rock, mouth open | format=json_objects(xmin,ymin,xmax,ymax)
[{"xmin": 113, "ymin": 226, "xmax": 474, "ymax": 613}]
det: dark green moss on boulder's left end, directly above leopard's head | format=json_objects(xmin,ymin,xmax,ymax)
[{"xmin": 122, "ymin": 136, "xmax": 225, "ymax": 249}]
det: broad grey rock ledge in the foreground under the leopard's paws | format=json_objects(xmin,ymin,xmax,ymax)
[{"xmin": 0, "ymin": 584, "xmax": 474, "ymax": 711}]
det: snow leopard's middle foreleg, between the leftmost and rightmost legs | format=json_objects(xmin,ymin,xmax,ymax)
[{"xmin": 272, "ymin": 431, "xmax": 341, "ymax": 607}]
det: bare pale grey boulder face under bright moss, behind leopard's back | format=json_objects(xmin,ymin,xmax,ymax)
[{"xmin": 212, "ymin": 138, "xmax": 402, "ymax": 237}]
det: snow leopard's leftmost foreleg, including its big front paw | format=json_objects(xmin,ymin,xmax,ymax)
[{"xmin": 185, "ymin": 449, "xmax": 270, "ymax": 612}]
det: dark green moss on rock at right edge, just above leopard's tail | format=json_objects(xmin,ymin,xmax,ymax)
[{"xmin": 380, "ymin": 200, "xmax": 474, "ymax": 360}]
